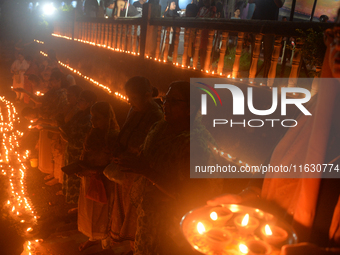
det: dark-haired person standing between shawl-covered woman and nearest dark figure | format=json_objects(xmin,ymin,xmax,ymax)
[{"xmin": 104, "ymin": 76, "xmax": 163, "ymax": 253}]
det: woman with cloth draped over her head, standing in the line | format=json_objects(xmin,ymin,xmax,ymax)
[{"xmin": 78, "ymin": 102, "xmax": 119, "ymax": 251}]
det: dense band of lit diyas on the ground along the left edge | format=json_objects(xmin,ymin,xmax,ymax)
[{"xmin": 0, "ymin": 97, "xmax": 42, "ymax": 255}]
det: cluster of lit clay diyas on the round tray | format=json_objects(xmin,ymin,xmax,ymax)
[{"xmin": 190, "ymin": 207, "xmax": 288, "ymax": 255}]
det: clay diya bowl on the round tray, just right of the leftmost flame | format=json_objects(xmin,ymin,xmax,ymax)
[{"xmin": 206, "ymin": 228, "xmax": 232, "ymax": 250}]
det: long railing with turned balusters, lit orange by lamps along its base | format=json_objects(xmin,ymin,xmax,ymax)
[{"xmin": 54, "ymin": 4, "xmax": 332, "ymax": 86}]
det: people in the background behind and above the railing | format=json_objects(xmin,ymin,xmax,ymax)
[{"xmin": 78, "ymin": 0, "xmax": 329, "ymax": 22}]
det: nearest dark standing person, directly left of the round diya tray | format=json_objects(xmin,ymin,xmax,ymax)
[{"xmin": 120, "ymin": 82, "xmax": 222, "ymax": 255}]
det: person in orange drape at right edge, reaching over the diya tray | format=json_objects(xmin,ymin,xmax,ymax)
[{"xmin": 208, "ymin": 10, "xmax": 340, "ymax": 254}]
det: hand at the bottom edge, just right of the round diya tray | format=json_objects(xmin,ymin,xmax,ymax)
[{"xmin": 281, "ymin": 243, "xmax": 327, "ymax": 255}]
